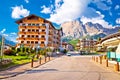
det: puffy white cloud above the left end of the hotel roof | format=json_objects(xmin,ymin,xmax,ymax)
[{"xmin": 12, "ymin": 5, "xmax": 30, "ymax": 19}]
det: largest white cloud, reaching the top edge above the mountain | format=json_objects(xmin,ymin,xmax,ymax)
[{"xmin": 48, "ymin": 0, "xmax": 91, "ymax": 24}]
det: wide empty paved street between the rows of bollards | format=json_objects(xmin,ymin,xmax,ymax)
[{"xmin": 4, "ymin": 55, "xmax": 120, "ymax": 80}]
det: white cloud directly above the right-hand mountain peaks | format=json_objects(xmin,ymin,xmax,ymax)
[{"xmin": 81, "ymin": 11, "xmax": 112, "ymax": 28}]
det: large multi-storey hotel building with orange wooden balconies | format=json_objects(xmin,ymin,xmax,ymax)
[{"xmin": 16, "ymin": 15, "xmax": 62, "ymax": 48}]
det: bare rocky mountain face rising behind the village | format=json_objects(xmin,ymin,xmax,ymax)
[{"xmin": 61, "ymin": 20, "xmax": 120, "ymax": 39}]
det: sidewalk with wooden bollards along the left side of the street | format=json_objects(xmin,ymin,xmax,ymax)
[{"xmin": 0, "ymin": 57, "xmax": 55, "ymax": 79}]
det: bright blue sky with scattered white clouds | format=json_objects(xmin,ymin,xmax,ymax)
[{"xmin": 0, "ymin": 0, "xmax": 120, "ymax": 42}]
